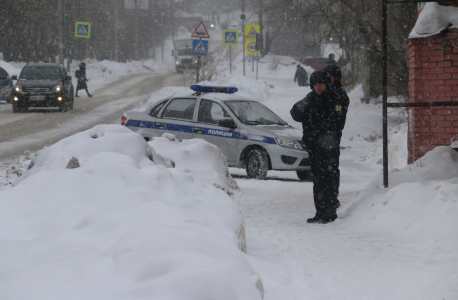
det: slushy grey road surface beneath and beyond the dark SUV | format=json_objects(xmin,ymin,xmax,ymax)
[{"xmin": 0, "ymin": 74, "xmax": 186, "ymax": 159}]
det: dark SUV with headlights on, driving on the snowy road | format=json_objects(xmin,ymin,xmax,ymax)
[{"xmin": 11, "ymin": 63, "xmax": 75, "ymax": 113}]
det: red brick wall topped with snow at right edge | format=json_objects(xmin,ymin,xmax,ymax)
[{"xmin": 407, "ymin": 28, "xmax": 458, "ymax": 163}]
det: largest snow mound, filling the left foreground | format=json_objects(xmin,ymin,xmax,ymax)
[{"xmin": 0, "ymin": 125, "xmax": 262, "ymax": 299}]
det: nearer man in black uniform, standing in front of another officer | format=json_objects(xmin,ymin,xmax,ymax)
[{"xmin": 291, "ymin": 70, "xmax": 349, "ymax": 224}]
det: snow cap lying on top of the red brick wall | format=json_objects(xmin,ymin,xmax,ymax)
[{"xmin": 409, "ymin": 2, "xmax": 458, "ymax": 39}]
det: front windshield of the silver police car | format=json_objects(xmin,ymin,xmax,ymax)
[{"xmin": 225, "ymin": 101, "xmax": 288, "ymax": 125}]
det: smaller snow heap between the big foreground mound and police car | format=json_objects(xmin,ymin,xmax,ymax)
[{"xmin": 148, "ymin": 133, "xmax": 238, "ymax": 194}]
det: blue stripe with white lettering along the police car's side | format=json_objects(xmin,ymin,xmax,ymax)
[{"xmin": 125, "ymin": 119, "xmax": 277, "ymax": 145}]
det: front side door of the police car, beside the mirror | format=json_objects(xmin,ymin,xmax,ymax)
[{"xmin": 193, "ymin": 99, "xmax": 238, "ymax": 162}]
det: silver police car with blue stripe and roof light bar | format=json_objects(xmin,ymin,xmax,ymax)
[{"xmin": 121, "ymin": 85, "xmax": 310, "ymax": 180}]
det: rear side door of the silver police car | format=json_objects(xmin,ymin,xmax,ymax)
[{"xmin": 154, "ymin": 98, "xmax": 197, "ymax": 140}]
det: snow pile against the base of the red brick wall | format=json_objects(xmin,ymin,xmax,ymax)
[{"xmin": 339, "ymin": 146, "xmax": 458, "ymax": 244}]
